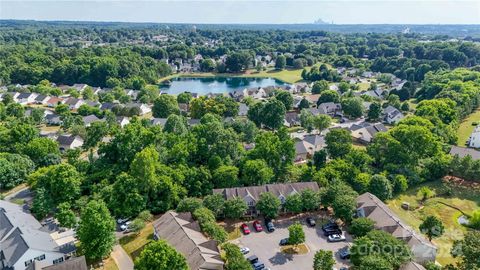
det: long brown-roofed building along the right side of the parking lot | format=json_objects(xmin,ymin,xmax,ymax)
[{"xmin": 357, "ymin": 192, "xmax": 437, "ymax": 262}]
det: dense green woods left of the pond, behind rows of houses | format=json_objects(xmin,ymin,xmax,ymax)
[{"xmin": 0, "ymin": 44, "xmax": 171, "ymax": 86}]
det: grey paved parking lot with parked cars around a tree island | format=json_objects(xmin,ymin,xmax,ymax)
[{"xmin": 232, "ymin": 220, "xmax": 352, "ymax": 270}]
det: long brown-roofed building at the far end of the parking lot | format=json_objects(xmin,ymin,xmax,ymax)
[{"xmin": 213, "ymin": 182, "xmax": 319, "ymax": 216}]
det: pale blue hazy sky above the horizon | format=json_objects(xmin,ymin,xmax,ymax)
[{"xmin": 0, "ymin": 0, "xmax": 480, "ymax": 24}]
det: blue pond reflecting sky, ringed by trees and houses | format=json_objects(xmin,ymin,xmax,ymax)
[{"xmin": 160, "ymin": 77, "xmax": 286, "ymax": 95}]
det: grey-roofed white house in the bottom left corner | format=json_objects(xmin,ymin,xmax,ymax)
[{"xmin": 0, "ymin": 201, "xmax": 71, "ymax": 270}]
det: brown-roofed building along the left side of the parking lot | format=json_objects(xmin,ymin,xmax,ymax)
[{"xmin": 153, "ymin": 211, "xmax": 224, "ymax": 270}]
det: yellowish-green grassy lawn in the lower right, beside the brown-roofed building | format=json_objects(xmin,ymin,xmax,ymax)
[{"xmin": 388, "ymin": 181, "xmax": 480, "ymax": 265}]
